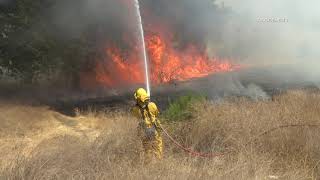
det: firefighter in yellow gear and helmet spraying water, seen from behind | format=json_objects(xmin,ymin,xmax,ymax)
[{"xmin": 132, "ymin": 88, "xmax": 163, "ymax": 159}]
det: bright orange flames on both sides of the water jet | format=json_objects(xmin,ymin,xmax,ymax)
[{"xmin": 83, "ymin": 33, "xmax": 238, "ymax": 87}]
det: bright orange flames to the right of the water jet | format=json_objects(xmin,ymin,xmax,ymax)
[{"xmin": 146, "ymin": 35, "xmax": 235, "ymax": 83}]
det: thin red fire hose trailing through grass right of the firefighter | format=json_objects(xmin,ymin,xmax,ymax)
[{"xmin": 160, "ymin": 124, "xmax": 320, "ymax": 158}]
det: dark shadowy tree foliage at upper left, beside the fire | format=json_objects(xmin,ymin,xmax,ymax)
[{"xmin": 0, "ymin": 0, "xmax": 90, "ymax": 86}]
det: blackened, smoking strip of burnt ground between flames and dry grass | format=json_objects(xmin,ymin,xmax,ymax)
[{"xmin": 0, "ymin": 65, "xmax": 320, "ymax": 116}]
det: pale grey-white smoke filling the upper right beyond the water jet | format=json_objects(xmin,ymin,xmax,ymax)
[{"xmin": 142, "ymin": 0, "xmax": 320, "ymax": 81}]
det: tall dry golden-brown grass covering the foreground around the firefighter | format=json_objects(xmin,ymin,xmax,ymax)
[{"xmin": 0, "ymin": 91, "xmax": 320, "ymax": 179}]
